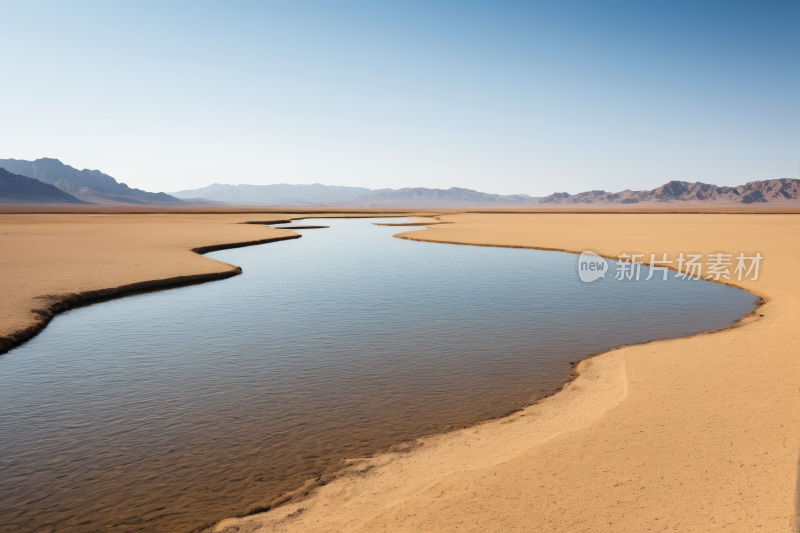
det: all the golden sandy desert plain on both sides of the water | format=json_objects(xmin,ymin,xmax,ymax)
[{"xmin": 0, "ymin": 207, "xmax": 800, "ymax": 532}]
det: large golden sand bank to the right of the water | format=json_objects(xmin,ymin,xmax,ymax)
[{"xmin": 214, "ymin": 213, "xmax": 800, "ymax": 532}]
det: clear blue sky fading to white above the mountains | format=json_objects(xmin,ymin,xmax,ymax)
[{"xmin": 0, "ymin": 0, "xmax": 800, "ymax": 196}]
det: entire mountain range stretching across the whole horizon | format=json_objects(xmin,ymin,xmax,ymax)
[{"xmin": 0, "ymin": 158, "xmax": 800, "ymax": 207}]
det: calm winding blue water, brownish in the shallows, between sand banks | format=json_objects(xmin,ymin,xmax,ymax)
[{"xmin": 0, "ymin": 219, "xmax": 754, "ymax": 532}]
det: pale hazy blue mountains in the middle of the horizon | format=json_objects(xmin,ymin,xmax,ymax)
[{"xmin": 172, "ymin": 183, "xmax": 537, "ymax": 207}]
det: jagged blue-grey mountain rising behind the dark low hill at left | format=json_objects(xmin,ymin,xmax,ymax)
[{"xmin": 0, "ymin": 157, "xmax": 184, "ymax": 205}]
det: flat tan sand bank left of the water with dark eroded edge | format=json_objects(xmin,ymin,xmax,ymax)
[{"xmin": 0, "ymin": 211, "xmax": 432, "ymax": 353}]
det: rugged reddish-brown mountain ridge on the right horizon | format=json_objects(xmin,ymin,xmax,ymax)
[{"xmin": 540, "ymin": 179, "xmax": 800, "ymax": 204}]
